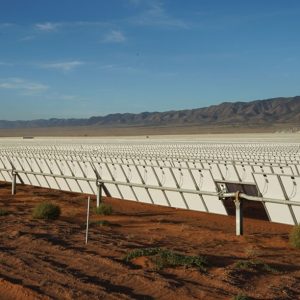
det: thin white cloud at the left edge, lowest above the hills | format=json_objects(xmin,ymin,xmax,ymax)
[{"xmin": 0, "ymin": 78, "xmax": 49, "ymax": 93}]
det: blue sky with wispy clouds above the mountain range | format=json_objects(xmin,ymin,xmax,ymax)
[{"xmin": 0, "ymin": 0, "xmax": 300, "ymax": 120}]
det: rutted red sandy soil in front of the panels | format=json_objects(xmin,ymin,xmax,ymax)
[{"xmin": 0, "ymin": 183, "xmax": 300, "ymax": 300}]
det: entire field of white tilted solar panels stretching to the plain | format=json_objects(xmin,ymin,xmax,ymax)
[{"xmin": 0, "ymin": 141, "xmax": 300, "ymax": 224}]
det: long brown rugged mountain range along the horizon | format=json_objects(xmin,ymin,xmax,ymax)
[{"xmin": 0, "ymin": 96, "xmax": 300, "ymax": 129}]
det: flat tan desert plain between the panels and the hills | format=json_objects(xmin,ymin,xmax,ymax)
[{"xmin": 0, "ymin": 123, "xmax": 300, "ymax": 137}]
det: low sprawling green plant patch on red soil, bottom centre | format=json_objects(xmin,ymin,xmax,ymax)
[{"xmin": 124, "ymin": 248, "xmax": 207, "ymax": 272}]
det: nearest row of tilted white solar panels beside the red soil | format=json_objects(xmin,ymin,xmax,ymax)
[{"xmin": 0, "ymin": 156, "xmax": 300, "ymax": 224}]
